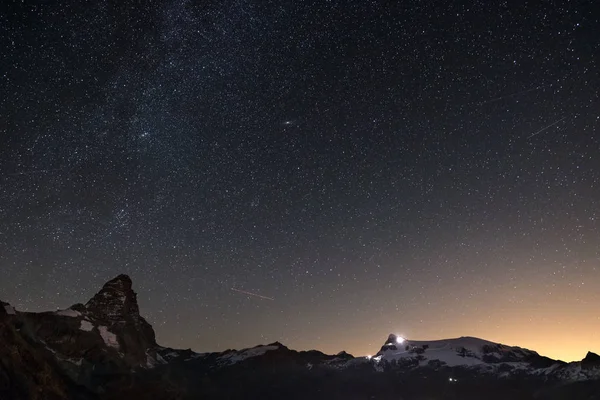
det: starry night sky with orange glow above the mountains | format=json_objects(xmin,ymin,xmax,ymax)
[{"xmin": 0, "ymin": 0, "xmax": 600, "ymax": 360}]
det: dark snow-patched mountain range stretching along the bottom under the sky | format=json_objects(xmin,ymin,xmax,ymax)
[{"xmin": 0, "ymin": 275, "xmax": 600, "ymax": 400}]
